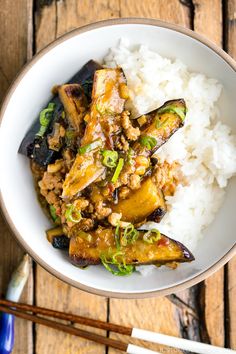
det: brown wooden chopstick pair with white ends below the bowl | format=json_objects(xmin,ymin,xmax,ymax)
[{"xmin": 0, "ymin": 299, "xmax": 236, "ymax": 354}]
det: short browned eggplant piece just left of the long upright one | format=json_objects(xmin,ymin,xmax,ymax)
[{"xmin": 58, "ymin": 84, "xmax": 87, "ymax": 132}]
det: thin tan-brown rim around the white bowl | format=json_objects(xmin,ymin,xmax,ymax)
[{"xmin": 0, "ymin": 17, "xmax": 236, "ymax": 299}]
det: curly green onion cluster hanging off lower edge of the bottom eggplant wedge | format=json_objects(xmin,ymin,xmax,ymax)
[{"xmin": 100, "ymin": 252, "xmax": 135, "ymax": 276}]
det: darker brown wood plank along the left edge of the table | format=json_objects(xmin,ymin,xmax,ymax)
[{"xmin": 0, "ymin": 0, "xmax": 33, "ymax": 354}]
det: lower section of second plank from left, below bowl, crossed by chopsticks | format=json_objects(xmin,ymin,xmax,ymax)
[{"xmin": 35, "ymin": 266, "xmax": 107, "ymax": 354}]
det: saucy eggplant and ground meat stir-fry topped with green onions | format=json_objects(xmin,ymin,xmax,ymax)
[{"xmin": 19, "ymin": 60, "xmax": 194, "ymax": 275}]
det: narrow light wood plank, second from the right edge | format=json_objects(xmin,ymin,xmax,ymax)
[{"xmin": 193, "ymin": 0, "xmax": 224, "ymax": 346}]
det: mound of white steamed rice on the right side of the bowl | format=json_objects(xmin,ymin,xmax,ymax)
[{"xmin": 105, "ymin": 40, "xmax": 236, "ymax": 258}]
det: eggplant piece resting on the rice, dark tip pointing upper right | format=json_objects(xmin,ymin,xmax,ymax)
[{"xmin": 133, "ymin": 99, "xmax": 186, "ymax": 156}]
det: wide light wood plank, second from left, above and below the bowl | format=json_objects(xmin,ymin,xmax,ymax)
[{"xmin": 35, "ymin": 0, "xmax": 109, "ymax": 354}]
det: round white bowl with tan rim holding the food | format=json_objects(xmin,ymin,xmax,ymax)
[{"xmin": 0, "ymin": 19, "xmax": 236, "ymax": 298}]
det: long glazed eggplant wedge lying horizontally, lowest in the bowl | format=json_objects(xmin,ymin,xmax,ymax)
[{"xmin": 69, "ymin": 227, "xmax": 194, "ymax": 266}]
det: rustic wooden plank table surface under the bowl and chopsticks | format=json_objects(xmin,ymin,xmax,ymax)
[{"xmin": 0, "ymin": 0, "xmax": 236, "ymax": 354}]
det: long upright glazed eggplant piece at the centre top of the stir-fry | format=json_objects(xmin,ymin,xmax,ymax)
[{"xmin": 62, "ymin": 69, "xmax": 125, "ymax": 199}]
